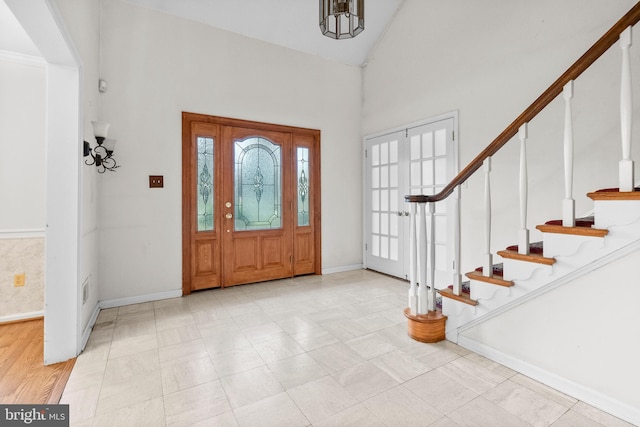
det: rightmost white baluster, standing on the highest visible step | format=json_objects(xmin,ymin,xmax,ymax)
[{"xmin": 619, "ymin": 27, "xmax": 634, "ymax": 191}]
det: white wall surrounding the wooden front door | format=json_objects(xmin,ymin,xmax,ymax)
[{"xmin": 98, "ymin": 0, "xmax": 362, "ymax": 300}]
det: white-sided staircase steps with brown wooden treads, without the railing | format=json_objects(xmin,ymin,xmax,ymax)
[{"xmin": 439, "ymin": 188, "xmax": 640, "ymax": 342}]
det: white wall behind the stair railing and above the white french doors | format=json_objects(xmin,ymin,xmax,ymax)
[{"xmin": 363, "ymin": 0, "xmax": 640, "ymax": 272}]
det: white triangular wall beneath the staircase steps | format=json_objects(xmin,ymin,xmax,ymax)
[{"xmin": 460, "ymin": 245, "xmax": 640, "ymax": 424}]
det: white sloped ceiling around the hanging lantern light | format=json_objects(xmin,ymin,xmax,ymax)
[{"xmin": 127, "ymin": 0, "xmax": 404, "ymax": 65}]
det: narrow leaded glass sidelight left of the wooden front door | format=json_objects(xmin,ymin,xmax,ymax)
[{"xmin": 196, "ymin": 136, "xmax": 214, "ymax": 231}]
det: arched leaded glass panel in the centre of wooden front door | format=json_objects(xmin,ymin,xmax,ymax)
[{"xmin": 234, "ymin": 137, "xmax": 282, "ymax": 231}]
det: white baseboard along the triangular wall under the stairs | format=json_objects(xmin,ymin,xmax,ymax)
[{"xmin": 458, "ymin": 335, "xmax": 640, "ymax": 425}]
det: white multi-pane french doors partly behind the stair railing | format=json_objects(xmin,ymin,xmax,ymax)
[{"xmin": 365, "ymin": 117, "xmax": 458, "ymax": 288}]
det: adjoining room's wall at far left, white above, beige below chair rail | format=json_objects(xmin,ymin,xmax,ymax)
[{"xmin": 0, "ymin": 53, "xmax": 46, "ymax": 321}]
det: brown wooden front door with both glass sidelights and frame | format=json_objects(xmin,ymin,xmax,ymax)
[{"xmin": 183, "ymin": 113, "xmax": 321, "ymax": 294}]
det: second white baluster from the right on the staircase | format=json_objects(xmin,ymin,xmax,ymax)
[{"xmin": 562, "ymin": 80, "xmax": 576, "ymax": 227}]
